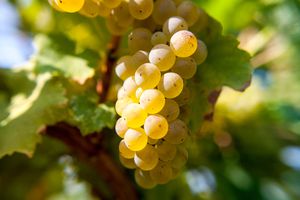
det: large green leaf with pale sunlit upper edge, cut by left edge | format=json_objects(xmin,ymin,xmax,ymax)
[{"xmin": 0, "ymin": 74, "xmax": 67, "ymax": 158}]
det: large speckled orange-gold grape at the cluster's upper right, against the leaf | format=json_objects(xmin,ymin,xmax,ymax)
[{"xmin": 170, "ymin": 30, "xmax": 197, "ymax": 57}]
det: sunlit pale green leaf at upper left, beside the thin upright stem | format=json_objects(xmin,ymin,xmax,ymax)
[{"xmin": 33, "ymin": 35, "xmax": 99, "ymax": 84}]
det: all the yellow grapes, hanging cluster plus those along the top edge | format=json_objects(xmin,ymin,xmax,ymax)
[{"xmin": 49, "ymin": 0, "xmax": 207, "ymax": 188}]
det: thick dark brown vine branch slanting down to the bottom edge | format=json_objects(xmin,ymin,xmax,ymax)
[{"xmin": 44, "ymin": 123, "xmax": 137, "ymax": 200}]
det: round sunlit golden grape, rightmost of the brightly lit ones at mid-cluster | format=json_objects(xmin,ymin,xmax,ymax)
[{"xmin": 157, "ymin": 72, "xmax": 183, "ymax": 99}]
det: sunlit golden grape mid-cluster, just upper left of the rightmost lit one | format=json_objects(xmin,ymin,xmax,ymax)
[{"xmin": 134, "ymin": 63, "xmax": 161, "ymax": 89}]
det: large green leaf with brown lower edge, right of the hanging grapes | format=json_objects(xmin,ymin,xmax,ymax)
[{"xmin": 190, "ymin": 17, "xmax": 251, "ymax": 131}]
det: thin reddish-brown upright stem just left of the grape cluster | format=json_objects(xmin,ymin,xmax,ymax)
[{"xmin": 97, "ymin": 36, "xmax": 121, "ymax": 103}]
